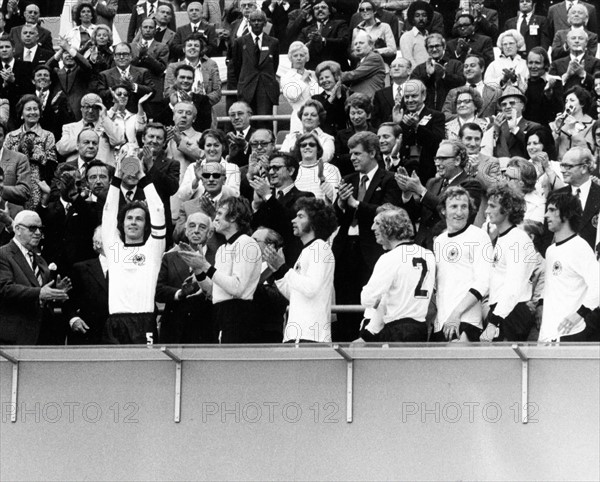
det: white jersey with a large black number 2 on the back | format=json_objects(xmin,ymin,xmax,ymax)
[{"xmin": 360, "ymin": 242, "xmax": 435, "ymax": 333}]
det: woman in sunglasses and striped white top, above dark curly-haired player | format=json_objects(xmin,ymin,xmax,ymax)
[{"xmin": 293, "ymin": 131, "xmax": 342, "ymax": 204}]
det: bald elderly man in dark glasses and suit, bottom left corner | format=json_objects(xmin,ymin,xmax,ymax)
[{"xmin": 0, "ymin": 210, "xmax": 71, "ymax": 345}]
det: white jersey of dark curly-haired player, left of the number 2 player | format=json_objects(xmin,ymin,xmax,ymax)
[{"xmin": 275, "ymin": 239, "xmax": 335, "ymax": 342}]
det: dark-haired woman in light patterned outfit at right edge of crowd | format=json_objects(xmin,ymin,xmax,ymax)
[{"xmin": 551, "ymin": 86, "xmax": 594, "ymax": 159}]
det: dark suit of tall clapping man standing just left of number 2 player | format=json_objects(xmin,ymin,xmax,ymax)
[{"xmin": 332, "ymin": 168, "xmax": 402, "ymax": 341}]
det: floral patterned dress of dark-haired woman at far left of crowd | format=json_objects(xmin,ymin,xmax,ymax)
[{"xmin": 4, "ymin": 124, "xmax": 57, "ymax": 211}]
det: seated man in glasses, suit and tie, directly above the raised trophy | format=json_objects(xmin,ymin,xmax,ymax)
[{"xmin": 91, "ymin": 43, "xmax": 155, "ymax": 113}]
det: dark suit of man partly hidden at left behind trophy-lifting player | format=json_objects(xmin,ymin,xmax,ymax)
[{"xmin": 65, "ymin": 258, "xmax": 108, "ymax": 345}]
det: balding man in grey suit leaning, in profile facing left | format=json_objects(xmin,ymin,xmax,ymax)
[{"xmin": 342, "ymin": 30, "xmax": 385, "ymax": 98}]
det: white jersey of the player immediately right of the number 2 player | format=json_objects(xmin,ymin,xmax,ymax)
[{"xmin": 433, "ymin": 225, "xmax": 492, "ymax": 332}]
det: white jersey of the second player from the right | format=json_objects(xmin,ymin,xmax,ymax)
[{"xmin": 485, "ymin": 226, "xmax": 536, "ymax": 318}]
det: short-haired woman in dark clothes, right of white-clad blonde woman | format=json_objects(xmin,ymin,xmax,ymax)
[{"xmin": 312, "ymin": 61, "xmax": 352, "ymax": 136}]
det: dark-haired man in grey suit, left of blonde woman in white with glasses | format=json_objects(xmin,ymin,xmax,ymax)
[{"xmin": 442, "ymin": 54, "xmax": 502, "ymax": 122}]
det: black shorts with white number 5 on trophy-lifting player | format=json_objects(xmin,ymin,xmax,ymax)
[{"xmin": 102, "ymin": 313, "xmax": 158, "ymax": 345}]
